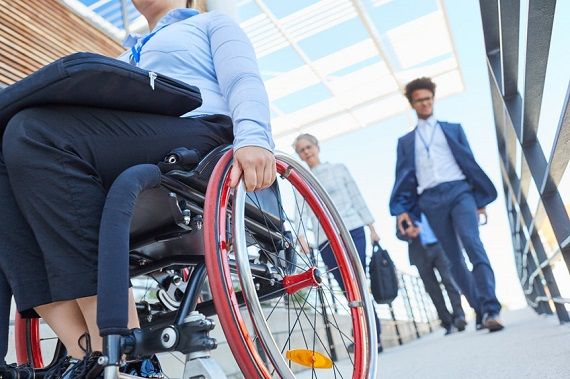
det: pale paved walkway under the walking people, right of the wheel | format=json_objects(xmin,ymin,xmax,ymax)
[{"xmin": 378, "ymin": 309, "xmax": 570, "ymax": 379}]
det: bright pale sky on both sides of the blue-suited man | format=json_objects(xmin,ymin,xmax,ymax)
[{"xmin": 278, "ymin": 1, "xmax": 526, "ymax": 308}]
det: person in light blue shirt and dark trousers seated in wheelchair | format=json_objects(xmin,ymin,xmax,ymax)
[{"xmin": 0, "ymin": 0, "xmax": 276, "ymax": 379}]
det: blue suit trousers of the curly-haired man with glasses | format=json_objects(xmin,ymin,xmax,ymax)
[{"xmin": 419, "ymin": 181, "xmax": 501, "ymax": 313}]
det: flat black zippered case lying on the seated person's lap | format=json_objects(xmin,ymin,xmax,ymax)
[{"xmin": 0, "ymin": 53, "xmax": 202, "ymax": 136}]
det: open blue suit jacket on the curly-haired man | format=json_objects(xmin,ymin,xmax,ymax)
[{"xmin": 390, "ymin": 121, "xmax": 497, "ymax": 219}]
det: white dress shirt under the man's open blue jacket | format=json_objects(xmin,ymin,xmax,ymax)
[{"xmin": 415, "ymin": 115, "xmax": 465, "ymax": 194}]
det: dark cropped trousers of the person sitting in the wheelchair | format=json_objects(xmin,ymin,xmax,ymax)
[{"xmin": 0, "ymin": 106, "xmax": 233, "ymax": 316}]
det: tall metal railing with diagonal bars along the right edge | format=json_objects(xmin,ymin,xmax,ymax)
[{"xmin": 480, "ymin": 0, "xmax": 570, "ymax": 323}]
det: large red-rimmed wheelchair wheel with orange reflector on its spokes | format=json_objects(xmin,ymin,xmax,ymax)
[{"xmin": 204, "ymin": 152, "xmax": 377, "ymax": 378}]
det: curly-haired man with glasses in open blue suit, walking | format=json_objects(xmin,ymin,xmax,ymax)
[{"xmin": 390, "ymin": 78, "xmax": 503, "ymax": 331}]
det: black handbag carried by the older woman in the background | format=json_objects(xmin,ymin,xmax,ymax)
[{"xmin": 368, "ymin": 242, "xmax": 398, "ymax": 304}]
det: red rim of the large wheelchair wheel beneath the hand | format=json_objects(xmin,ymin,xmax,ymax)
[{"xmin": 204, "ymin": 151, "xmax": 366, "ymax": 378}]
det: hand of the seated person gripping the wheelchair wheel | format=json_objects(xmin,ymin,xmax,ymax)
[{"xmin": 230, "ymin": 146, "xmax": 277, "ymax": 192}]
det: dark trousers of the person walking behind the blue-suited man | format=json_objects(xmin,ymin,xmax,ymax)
[{"xmin": 410, "ymin": 240, "xmax": 465, "ymax": 328}]
